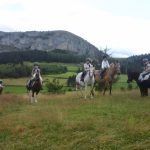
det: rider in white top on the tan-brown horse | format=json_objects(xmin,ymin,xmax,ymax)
[{"xmin": 100, "ymin": 55, "xmax": 110, "ymax": 79}]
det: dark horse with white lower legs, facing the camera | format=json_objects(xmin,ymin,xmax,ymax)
[{"xmin": 26, "ymin": 73, "xmax": 42, "ymax": 103}]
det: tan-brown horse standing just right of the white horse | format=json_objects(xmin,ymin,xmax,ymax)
[{"xmin": 95, "ymin": 63, "xmax": 120, "ymax": 95}]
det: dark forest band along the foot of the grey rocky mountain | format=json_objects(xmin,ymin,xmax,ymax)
[{"xmin": 0, "ymin": 50, "xmax": 85, "ymax": 64}]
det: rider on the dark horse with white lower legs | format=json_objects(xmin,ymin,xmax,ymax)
[{"xmin": 29, "ymin": 63, "xmax": 43, "ymax": 87}]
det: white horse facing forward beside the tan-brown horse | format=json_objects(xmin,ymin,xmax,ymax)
[{"xmin": 76, "ymin": 67, "xmax": 95, "ymax": 99}]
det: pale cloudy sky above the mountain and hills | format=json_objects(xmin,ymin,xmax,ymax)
[{"xmin": 0, "ymin": 0, "xmax": 150, "ymax": 57}]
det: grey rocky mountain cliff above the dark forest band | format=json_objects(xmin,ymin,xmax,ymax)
[{"xmin": 0, "ymin": 31, "xmax": 103, "ymax": 58}]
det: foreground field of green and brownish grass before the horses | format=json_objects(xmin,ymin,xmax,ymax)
[{"xmin": 0, "ymin": 90, "xmax": 150, "ymax": 150}]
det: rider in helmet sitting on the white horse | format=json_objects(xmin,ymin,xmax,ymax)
[{"xmin": 81, "ymin": 58, "xmax": 93, "ymax": 81}]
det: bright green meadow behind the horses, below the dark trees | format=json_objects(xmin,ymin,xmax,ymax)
[{"xmin": 3, "ymin": 62, "xmax": 137, "ymax": 94}]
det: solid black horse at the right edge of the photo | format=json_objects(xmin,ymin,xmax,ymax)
[{"xmin": 127, "ymin": 71, "xmax": 150, "ymax": 96}]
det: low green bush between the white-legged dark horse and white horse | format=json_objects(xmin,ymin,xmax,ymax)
[{"xmin": 46, "ymin": 79, "xmax": 65, "ymax": 93}]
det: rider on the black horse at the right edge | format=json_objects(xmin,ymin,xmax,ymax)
[{"xmin": 139, "ymin": 58, "xmax": 150, "ymax": 81}]
